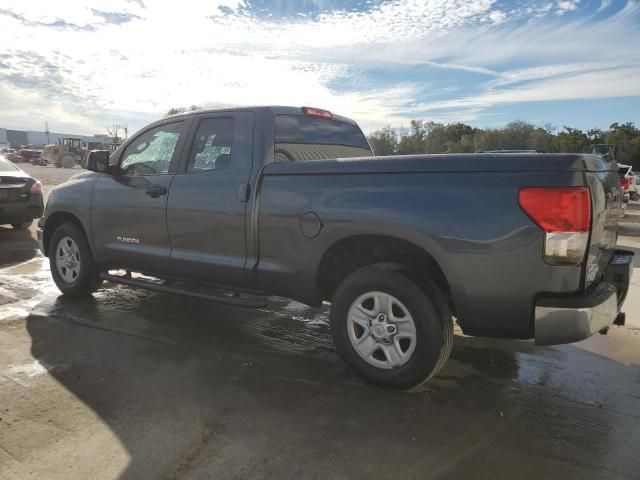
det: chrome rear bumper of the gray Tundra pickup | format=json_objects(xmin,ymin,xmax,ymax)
[{"xmin": 535, "ymin": 250, "xmax": 633, "ymax": 345}]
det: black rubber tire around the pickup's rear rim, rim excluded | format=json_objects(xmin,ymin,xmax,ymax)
[{"xmin": 331, "ymin": 265, "xmax": 454, "ymax": 390}]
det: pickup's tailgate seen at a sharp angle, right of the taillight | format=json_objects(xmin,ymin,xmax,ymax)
[{"xmin": 585, "ymin": 158, "xmax": 622, "ymax": 287}]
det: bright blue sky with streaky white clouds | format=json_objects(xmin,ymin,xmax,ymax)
[{"xmin": 0, "ymin": 0, "xmax": 640, "ymax": 134}]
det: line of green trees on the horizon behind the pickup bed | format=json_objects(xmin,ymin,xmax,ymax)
[{"xmin": 367, "ymin": 120, "xmax": 640, "ymax": 170}]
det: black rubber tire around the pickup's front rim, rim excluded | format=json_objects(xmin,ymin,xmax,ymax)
[{"xmin": 49, "ymin": 223, "xmax": 102, "ymax": 297}]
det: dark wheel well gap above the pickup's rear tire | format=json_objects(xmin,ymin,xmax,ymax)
[{"xmin": 316, "ymin": 235, "xmax": 453, "ymax": 307}]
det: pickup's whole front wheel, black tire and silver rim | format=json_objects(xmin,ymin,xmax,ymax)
[{"xmin": 49, "ymin": 223, "xmax": 102, "ymax": 297}]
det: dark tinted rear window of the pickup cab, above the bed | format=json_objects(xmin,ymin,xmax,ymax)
[{"xmin": 274, "ymin": 115, "xmax": 373, "ymax": 162}]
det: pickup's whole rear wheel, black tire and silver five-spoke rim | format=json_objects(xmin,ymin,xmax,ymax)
[{"xmin": 331, "ymin": 265, "xmax": 453, "ymax": 389}]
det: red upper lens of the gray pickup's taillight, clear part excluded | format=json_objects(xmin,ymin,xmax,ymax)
[{"xmin": 518, "ymin": 187, "xmax": 591, "ymax": 232}]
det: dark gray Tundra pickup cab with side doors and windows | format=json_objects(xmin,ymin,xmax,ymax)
[{"xmin": 38, "ymin": 107, "xmax": 372, "ymax": 289}]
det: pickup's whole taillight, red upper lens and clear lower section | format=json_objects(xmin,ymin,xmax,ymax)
[{"xmin": 518, "ymin": 187, "xmax": 591, "ymax": 265}]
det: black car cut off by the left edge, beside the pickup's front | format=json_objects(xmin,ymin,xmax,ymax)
[{"xmin": 0, "ymin": 157, "xmax": 44, "ymax": 228}]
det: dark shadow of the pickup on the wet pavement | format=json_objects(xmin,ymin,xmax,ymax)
[{"xmin": 27, "ymin": 287, "xmax": 640, "ymax": 479}]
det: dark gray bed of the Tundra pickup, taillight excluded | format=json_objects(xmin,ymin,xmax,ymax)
[{"xmin": 255, "ymin": 154, "xmax": 619, "ymax": 338}]
